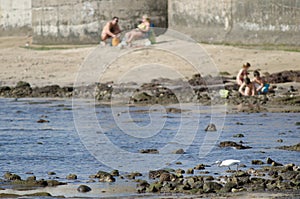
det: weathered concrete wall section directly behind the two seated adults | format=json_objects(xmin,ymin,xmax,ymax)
[{"xmin": 32, "ymin": 0, "xmax": 168, "ymax": 44}]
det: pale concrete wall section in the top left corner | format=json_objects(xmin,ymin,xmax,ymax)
[{"xmin": 0, "ymin": 0, "xmax": 32, "ymax": 36}]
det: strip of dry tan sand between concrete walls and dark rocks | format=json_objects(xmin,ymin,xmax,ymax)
[{"xmin": 0, "ymin": 36, "xmax": 300, "ymax": 86}]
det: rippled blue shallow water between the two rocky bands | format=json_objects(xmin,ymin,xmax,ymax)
[{"xmin": 0, "ymin": 99, "xmax": 300, "ymax": 197}]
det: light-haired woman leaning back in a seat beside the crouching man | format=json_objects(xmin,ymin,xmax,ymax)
[{"xmin": 122, "ymin": 15, "xmax": 150, "ymax": 46}]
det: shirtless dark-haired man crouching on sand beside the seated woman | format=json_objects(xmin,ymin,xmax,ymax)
[{"xmin": 101, "ymin": 17, "xmax": 121, "ymax": 45}]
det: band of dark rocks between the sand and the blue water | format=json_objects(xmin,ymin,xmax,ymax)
[{"xmin": 0, "ymin": 71, "xmax": 300, "ymax": 112}]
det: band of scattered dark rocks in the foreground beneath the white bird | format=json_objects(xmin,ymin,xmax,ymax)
[{"xmin": 0, "ymin": 155, "xmax": 300, "ymax": 198}]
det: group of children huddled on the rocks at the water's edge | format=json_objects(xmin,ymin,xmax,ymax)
[{"xmin": 236, "ymin": 62, "xmax": 269, "ymax": 96}]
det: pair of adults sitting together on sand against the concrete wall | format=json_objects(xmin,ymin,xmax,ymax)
[{"xmin": 101, "ymin": 15, "xmax": 151, "ymax": 46}]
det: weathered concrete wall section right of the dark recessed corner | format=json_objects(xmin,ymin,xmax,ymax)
[{"xmin": 168, "ymin": 0, "xmax": 300, "ymax": 45}]
